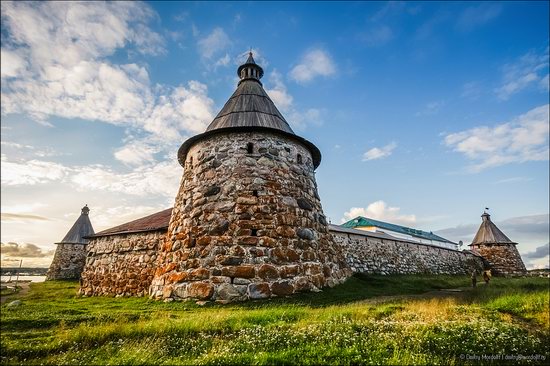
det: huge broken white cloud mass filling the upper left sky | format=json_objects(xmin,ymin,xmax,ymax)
[{"xmin": 2, "ymin": 2, "xmax": 213, "ymax": 147}]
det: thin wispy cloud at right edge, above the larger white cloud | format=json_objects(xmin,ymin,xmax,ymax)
[{"xmin": 495, "ymin": 47, "xmax": 549, "ymax": 100}]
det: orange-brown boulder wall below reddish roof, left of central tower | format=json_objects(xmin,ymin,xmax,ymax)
[{"xmin": 80, "ymin": 231, "xmax": 166, "ymax": 296}]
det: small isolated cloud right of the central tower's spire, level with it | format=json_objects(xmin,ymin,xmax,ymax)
[{"xmin": 290, "ymin": 48, "xmax": 336, "ymax": 83}]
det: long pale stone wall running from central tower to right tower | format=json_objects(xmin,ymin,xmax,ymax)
[{"xmin": 331, "ymin": 230, "xmax": 484, "ymax": 275}]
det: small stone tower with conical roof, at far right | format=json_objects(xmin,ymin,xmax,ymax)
[{"xmin": 470, "ymin": 212, "xmax": 527, "ymax": 275}]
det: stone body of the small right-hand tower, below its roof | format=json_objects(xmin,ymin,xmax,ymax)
[{"xmin": 472, "ymin": 244, "xmax": 527, "ymax": 276}]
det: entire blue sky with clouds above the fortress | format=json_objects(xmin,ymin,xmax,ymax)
[{"xmin": 1, "ymin": 2, "xmax": 549, "ymax": 267}]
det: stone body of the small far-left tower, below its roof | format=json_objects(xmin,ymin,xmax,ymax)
[{"xmin": 46, "ymin": 243, "xmax": 86, "ymax": 280}]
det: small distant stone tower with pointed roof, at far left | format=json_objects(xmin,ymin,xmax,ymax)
[{"xmin": 46, "ymin": 205, "xmax": 94, "ymax": 280}]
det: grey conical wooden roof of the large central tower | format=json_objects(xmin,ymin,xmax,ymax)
[{"xmin": 178, "ymin": 53, "xmax": 321, "ymax": 168}]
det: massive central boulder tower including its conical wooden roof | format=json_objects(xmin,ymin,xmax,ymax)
[{"xmin": 150, "ymin": 53, "xmax": 351, "ymax": 301}]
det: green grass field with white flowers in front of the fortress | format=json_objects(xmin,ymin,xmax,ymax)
[{"xmin": 0, "ymin": 276, "xmax": 550, "ymax": 365}]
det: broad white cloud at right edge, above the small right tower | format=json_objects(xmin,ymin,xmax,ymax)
[{"xmin": 444, "ymin": 104, "xmax": 549, "ymax": 172}]
